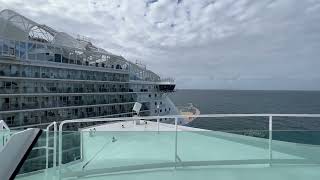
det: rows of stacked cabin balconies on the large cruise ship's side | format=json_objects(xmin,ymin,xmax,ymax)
[{"xmin": 0, "ymin": 39, "xmax": 157, "ymax": 127}]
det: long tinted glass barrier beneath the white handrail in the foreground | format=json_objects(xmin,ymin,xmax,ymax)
[{"xmin": 13, "ymin": 131, "xmax": 320, "ymax": 178}]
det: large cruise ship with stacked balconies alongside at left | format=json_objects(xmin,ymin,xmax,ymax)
[{"xmin": 0, "ymin": 10, "xmax": 177, "ymax": 128}]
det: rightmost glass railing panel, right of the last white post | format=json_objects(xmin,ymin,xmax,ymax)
[{"xmin": 272, "ymin": 117, "xmax": 320, "ymax": 164}]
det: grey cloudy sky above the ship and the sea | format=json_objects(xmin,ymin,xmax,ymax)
[{"xmin": 0, "ymin": 0, "xmax": 320, "ymax": 90}]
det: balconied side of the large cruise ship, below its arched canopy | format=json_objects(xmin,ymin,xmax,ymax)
[{"xmin": 0, "ymin": 34, "xmax": 173, "ymax": 173}]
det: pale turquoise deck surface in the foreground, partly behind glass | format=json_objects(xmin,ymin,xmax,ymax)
[{"xmin": 18, "ymin": 131, "xmax": 320, "ymax": 180}]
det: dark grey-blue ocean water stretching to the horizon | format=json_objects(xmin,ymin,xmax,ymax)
[{"xmin": 170, "ymin": 90, "xmax": 320, "ymax": 145}]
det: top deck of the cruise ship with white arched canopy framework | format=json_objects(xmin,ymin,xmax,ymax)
[{"xmin": 0, "ymin": 9, "xmax": 165, "ymax": 82}]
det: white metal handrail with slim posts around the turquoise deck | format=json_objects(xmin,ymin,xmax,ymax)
[{"xmin": 58, "ymin": 114, "xmax": 320, "ymax": 177}]
